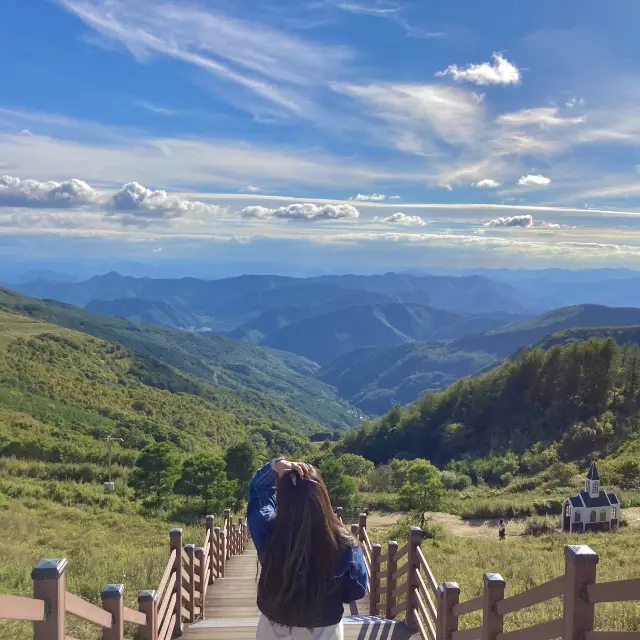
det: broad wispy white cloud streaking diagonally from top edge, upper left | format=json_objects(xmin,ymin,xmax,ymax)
[{"xmin": 59, "ymin": 0, "xmax": 351, "ymax": 116}]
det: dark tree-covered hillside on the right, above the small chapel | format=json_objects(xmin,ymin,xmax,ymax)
[{"xmin": 345, "ymin": 338, "xmax": 640, "ymax": 465}]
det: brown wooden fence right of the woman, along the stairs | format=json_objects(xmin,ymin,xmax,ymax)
[{"xmin": 348, "ymin": 509, "xmax": 640, "ymax": 640}]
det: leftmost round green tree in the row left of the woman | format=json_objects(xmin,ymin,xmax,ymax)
[{"xmin": 131, "ymin": 442, "xmax": 182, "ymax": 507}]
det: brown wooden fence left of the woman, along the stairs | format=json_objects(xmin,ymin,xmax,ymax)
[{"xmin": 0, "ymin": 510, "xmax": 248, "ymax": 640}]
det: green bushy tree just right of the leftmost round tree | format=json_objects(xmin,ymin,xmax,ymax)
[{"xmin": 176, "ymin": 453, "xmax": 237, "ymax": 513}]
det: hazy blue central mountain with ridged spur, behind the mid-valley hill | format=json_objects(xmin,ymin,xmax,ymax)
[{"xmin": 262, "ymin": 303, "xmax": 504, "ymax": 364}]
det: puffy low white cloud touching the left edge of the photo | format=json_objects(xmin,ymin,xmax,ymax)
[{"xmin": 0, "ymin": 176, "xmax": 99, "ymax": 209}]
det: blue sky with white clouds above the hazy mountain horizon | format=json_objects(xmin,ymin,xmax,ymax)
[{"xmin": 0, "ymin": 0, "xmax": 640, "ymax": 269}]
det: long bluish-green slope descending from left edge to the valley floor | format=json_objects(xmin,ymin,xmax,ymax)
[{"xmin": 0, "ymin": 288, "xmax": 360, "ymax": 432}]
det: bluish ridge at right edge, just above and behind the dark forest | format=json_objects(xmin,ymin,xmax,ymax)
[{"xmin": 451, "ymin": 304, "xmax": 640, "ymax": 357}]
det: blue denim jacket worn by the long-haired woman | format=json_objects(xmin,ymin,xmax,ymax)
[{"xmin": 247, "ymin": 462, "xmax": 368, "ymax": 627}]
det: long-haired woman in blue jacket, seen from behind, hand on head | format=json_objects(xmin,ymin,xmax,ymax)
[{"xmin": 247, "ymin": 458, "xmax": 368, "ymax": 640}]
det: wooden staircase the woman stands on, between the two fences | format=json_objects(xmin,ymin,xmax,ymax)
[{"xmin": 182, "ymin": 543, "xmax": 418, "ymax": 640}]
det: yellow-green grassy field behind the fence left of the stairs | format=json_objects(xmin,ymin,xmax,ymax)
[{"xmin": 0, "ymin": 498, "xmax": 211, "ymax": 640}]
